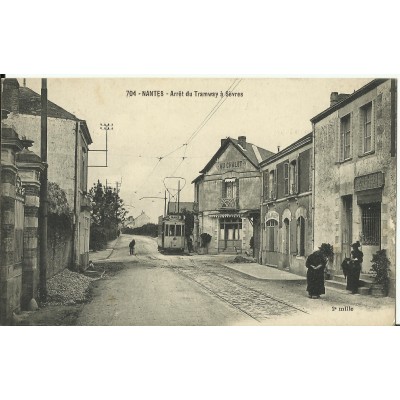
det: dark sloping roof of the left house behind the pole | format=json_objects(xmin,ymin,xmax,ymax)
[{"xmin": 19, "ymin": 87, "xmax": 93, "ymax": 144}]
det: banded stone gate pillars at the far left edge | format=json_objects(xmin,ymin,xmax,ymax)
[{"xmin": 0, "ymin": 124, "xmax": 45, "ymax": 324}]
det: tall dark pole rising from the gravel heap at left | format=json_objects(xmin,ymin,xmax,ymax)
[{"xmin": 39, "ymin": 78, "xmax": 48, "ymax": 301}]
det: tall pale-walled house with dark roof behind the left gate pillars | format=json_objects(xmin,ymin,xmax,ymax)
[{"xmin": 2, "ymin": 79, "xmax": 92, "ymax": 272}]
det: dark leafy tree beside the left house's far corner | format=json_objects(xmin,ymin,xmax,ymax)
[{"xmin": 89, "ymin": 181, "xmax": 127, "ymax": 250}]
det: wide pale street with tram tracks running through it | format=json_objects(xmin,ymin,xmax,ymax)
[{"xmin": 77, "ymin": 235, "xmax": 393, "ymax": 326}]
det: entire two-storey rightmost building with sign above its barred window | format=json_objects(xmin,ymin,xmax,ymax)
[{"xmin": 311, "ymin": 79, "xmax": 397, "ymax": 293}]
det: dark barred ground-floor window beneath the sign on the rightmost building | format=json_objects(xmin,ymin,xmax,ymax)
[{"xmin": 361, "ymin": 203, "xmax": 381, "ymax": 246}]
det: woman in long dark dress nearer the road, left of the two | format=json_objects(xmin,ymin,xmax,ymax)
[{"xmin": 306, "ymin": 250, "xmax": 328, "ymax": 299}]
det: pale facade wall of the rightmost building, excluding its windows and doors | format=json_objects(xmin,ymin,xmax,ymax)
[{"xmin": 314, "ymin": 80, "xmax": 397, "ymax": 293}]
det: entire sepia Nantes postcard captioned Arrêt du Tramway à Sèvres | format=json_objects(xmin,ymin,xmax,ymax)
[{"xmin": 0, "ymin": 76, "xmax": 397, "ymax": 326}]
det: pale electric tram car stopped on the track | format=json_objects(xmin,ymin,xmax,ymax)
[{"xmin": 157, "ymin": 214, "xmax": 185, "ymax": 253}]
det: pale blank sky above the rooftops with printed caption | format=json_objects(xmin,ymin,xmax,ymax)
[{"xmin": 19, "ymin": 77, "xmax": 371, "ymax": 222}]
